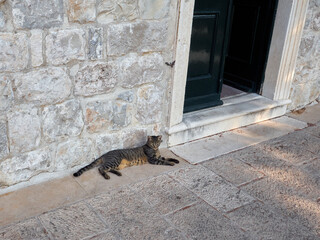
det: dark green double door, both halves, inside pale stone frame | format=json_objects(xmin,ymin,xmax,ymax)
[{"xmin": 184, "ymin": 0, "xmax": 277, "ymax": 112}]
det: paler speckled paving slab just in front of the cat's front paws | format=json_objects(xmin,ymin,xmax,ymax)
[{"xmin": 169, "ymin": 165, "xmax": 255, "ymax": 212}]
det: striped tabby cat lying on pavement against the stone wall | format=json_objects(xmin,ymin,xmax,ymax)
[{"xmin": 73, "ymin": 136, "xmax": 179, "ymax": 179}]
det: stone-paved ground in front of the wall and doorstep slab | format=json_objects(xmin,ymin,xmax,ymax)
[{"xmin": 0, "ymin": 106, "xmax": 320, "ymax": 240}]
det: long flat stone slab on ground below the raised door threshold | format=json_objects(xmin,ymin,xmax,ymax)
[{"xmin": 170, "ymin": 116, "xmax": 307, "ymax": 164}]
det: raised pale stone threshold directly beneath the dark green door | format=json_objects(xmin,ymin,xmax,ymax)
[{"xmin": 167, "ymin": 93, "xmax": 291, "ymax": 147}]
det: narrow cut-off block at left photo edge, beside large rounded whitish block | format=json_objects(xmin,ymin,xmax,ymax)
[{"xmin": 0, "ymin": 75, "xmax": 14, "ymax": 112}]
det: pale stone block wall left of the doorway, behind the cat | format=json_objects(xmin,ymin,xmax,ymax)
[{"xmin": 0, "ymin": 0, "xmax": 177, "ymax": 188}]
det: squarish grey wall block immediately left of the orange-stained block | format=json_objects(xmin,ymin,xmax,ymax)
[{"xmin": 42, "ymin": 100, "xmax": 84, "ymax": 142}]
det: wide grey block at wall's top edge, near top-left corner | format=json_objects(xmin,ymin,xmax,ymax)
[{"xmin": 12, "ymin": 0, "xmax": 63, "ymax": 29}]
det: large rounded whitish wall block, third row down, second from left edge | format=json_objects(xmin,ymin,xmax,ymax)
[{"xmin": 15, "ymin": 67, "xmax": 71, "ymax": 105}]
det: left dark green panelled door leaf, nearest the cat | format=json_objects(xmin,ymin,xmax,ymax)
[{"xmin": 184, "ymin": 0, "xmax": 231, "ymax": 112}]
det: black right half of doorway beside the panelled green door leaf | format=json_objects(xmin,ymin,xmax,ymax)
[{"xmin": 224, "ymin": 0, "xmax": 277, "ymax": 93}]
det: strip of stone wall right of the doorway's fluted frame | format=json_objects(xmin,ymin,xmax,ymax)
[{"xmin": 289, "ymin": 0, "xmax": 320, "ymax": 110}]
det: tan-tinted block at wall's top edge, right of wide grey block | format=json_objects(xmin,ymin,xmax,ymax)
[{"xmin": 68, "ymin": 0, "xmax": 96, "ymax": 23}]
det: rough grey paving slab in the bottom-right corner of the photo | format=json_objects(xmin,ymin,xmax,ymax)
[{"xmin": 227, "ymin": 202, "xmax": 316, "ymax": 240}]
